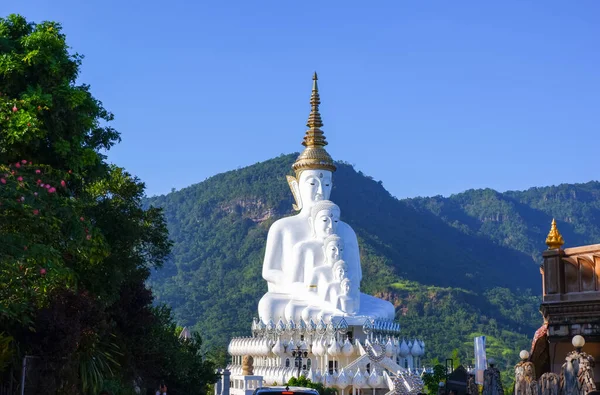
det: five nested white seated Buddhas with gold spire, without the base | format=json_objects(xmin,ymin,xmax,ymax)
[{"xmin": 258, "ymin": 73, "xmax": 394, "ymax": 321}]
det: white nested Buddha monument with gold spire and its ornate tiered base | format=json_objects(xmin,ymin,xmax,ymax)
[{"xmin": 217, "ymin": 73, "xmax": 425, "ymax": 395}]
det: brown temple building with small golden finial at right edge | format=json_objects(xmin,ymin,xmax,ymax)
[{"xmin": 529, "ymin": 220, "xmax": 600, "ymax": 388}]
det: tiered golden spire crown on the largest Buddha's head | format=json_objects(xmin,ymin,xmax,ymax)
[{"xmin": 292, "ymin": 72, "xmax": 335, "ymax": 176}]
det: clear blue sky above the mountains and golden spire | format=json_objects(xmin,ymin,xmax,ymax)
[{"xmin": 0, "ymin": 0, "xmax": 600, "ymax": 198}]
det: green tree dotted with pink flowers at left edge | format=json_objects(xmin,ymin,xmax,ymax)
[{"xmin": 0, "ymin": 160, "xmax": 108, "ymax": 325}]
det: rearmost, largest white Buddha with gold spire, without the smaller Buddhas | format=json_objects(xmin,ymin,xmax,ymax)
[{"xmin": 258, "ymin": 73, "xmax": 394, "ymax": 321}]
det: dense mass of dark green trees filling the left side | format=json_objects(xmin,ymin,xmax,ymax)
[{"xmin": 0, "ymin": 15, "xmax": 216, "ymax": 394}]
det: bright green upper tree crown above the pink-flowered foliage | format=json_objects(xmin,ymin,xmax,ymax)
[{"xmin": 0, "ymin": 15, "xmax": 119, "ymax": 181}]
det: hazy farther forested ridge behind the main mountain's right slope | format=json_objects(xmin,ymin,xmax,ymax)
[{"xmin": 406, "ymin": 182, "xmax": 600, "ymax": 261}]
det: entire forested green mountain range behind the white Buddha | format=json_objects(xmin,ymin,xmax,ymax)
[{"xmin": 145, "ymin": 154, "xmax": 600, "ymax": 386}]
